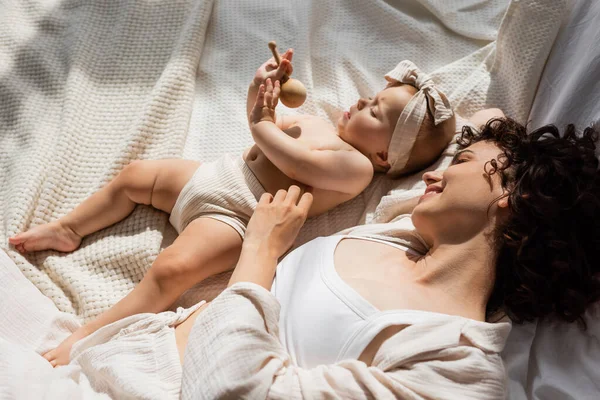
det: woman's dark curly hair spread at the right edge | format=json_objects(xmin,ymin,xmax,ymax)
[{"xmin": 458, "ymin": 118, "xmax": 600, "ymax": 327}]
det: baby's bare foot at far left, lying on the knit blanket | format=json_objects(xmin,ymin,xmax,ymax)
[{"xmin": 8, "ymin": 221, "xmax": 81, "ymax": 253}]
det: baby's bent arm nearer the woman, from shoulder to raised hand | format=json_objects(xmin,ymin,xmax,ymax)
[{"xmin": 250, "ymin": 79, "xmax": 373, "ymax": 195}]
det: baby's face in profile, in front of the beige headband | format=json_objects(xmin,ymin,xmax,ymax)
[{"xmin": 337, "ymin": 85, "xmax": 416, "ymax": 156}]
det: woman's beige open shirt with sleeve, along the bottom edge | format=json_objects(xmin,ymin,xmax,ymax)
[{"xmin": 182, "ymin": 283, "xmax": 511, "ymax": 399}]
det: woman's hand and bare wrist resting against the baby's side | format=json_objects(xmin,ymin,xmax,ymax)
[{"xmin": 228, "ymin": 185, "xmax": 313, "ymax": 290}]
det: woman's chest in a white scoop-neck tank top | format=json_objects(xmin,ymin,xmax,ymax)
[{"xmin": 272, "ymin": 236, "xmax": 423, "ymax": 367}]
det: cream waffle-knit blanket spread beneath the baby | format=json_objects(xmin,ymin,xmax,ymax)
[{"xmin": 0, "ymin": 0, "xmax": 566, "ymax": 320}]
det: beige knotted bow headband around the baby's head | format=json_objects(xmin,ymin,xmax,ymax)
[{"xmin": 385, "ymin": 60, "xmax": 454, "ymax": 176}]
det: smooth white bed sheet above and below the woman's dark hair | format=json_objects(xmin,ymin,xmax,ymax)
[{"xmin": 504, "ymin": 0, "xmax": 600, "ymax": 400}]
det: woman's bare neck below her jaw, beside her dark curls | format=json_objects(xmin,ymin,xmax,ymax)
[{"xmin": 414, "ymin": 234, "xmax": 495, "ymax": 320}]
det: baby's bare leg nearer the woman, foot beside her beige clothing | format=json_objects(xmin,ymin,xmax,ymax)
[{"xmin": 44, "ymin": 218, "xmax": 242, "ymax": 366}]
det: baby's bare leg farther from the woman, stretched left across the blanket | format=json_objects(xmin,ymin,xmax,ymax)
[{"xmin": 9, "ymin": 160, "xmax": 200, "ymax": 252}]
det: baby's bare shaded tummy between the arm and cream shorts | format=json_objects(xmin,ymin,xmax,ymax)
[{"xmin": 243, "ymin": 145, "xmax": 350, "ymax": 217}]
